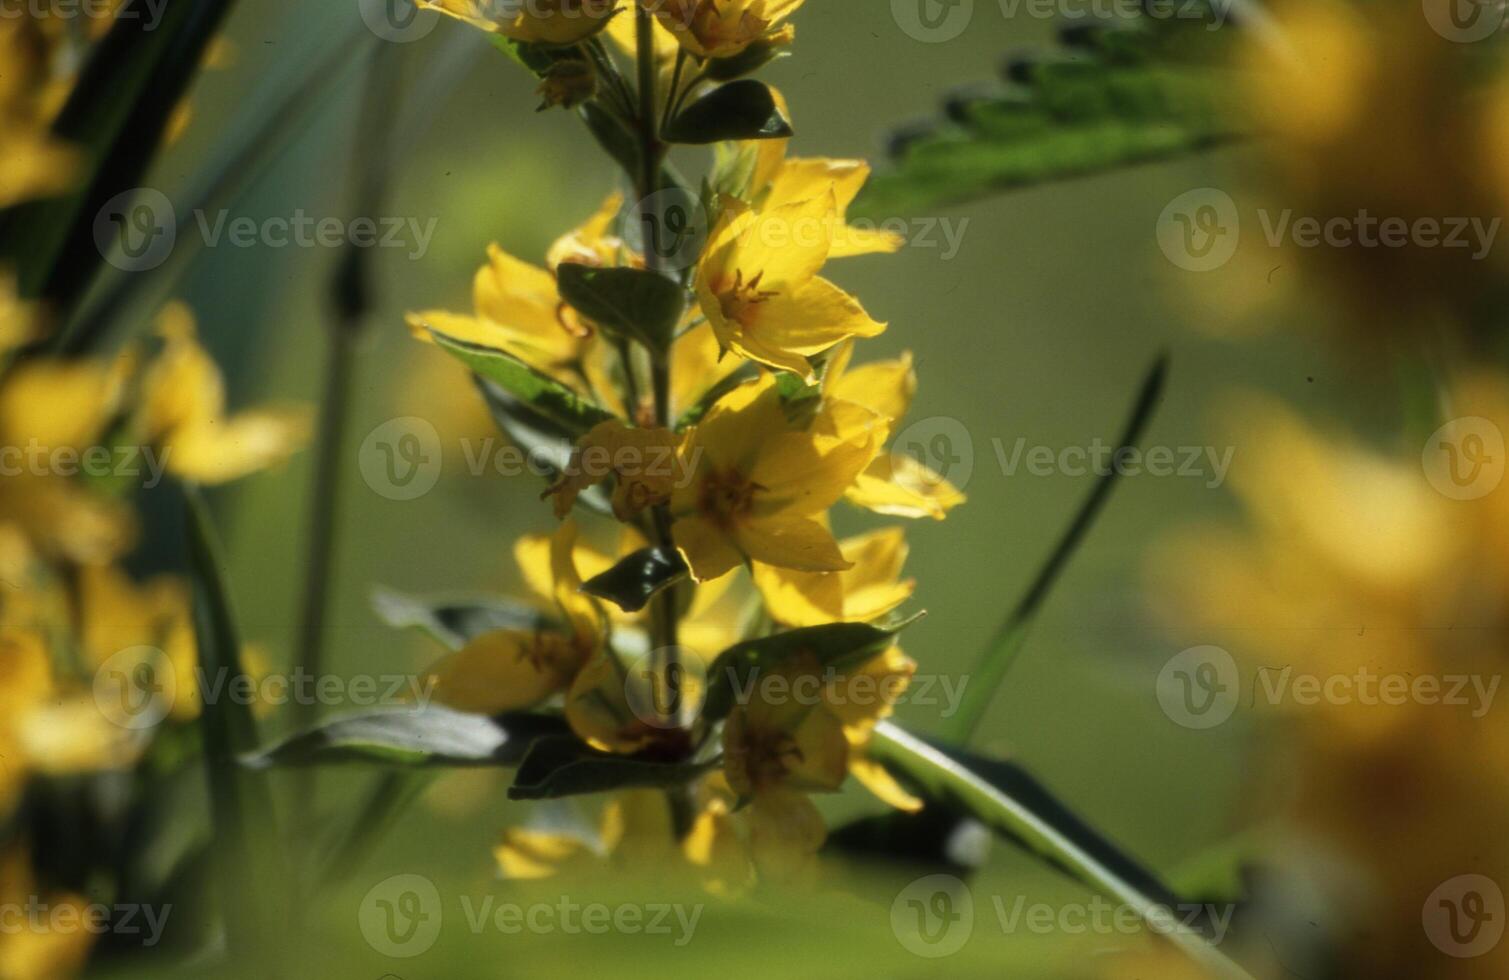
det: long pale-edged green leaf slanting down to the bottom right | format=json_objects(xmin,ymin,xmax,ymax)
[{"xmin": 869, "ymin": 722, "xmax": 1251, "ymax": 980}]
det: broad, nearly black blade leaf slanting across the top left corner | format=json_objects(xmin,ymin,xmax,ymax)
[{"xmin": 0, "ymin": 0, "xmax": 241, "ymax": 322}]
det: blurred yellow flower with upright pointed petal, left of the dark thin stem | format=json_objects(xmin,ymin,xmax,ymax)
[{"xmin": 133, "ymin": 297, "xmax": 309, "ymax": 483}]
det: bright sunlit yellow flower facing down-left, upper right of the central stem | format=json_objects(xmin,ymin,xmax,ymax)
[{"xmin": 696, "ymin": 189, "xmax": 886, "ymax": 382}]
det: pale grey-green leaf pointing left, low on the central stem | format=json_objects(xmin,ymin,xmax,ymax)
[{"xmin": 241, "ymin": 705, "xmax": 567, "ymax": 769}]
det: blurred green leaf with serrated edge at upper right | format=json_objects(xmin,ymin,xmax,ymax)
[{"xmin": 851, "ymin": 12, "xmax": 1251, "ymax": 219}]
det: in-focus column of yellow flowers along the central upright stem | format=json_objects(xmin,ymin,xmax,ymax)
[{"xmin": 409, "ymin": 0, "xmax": 963, "ymax": 888}]
